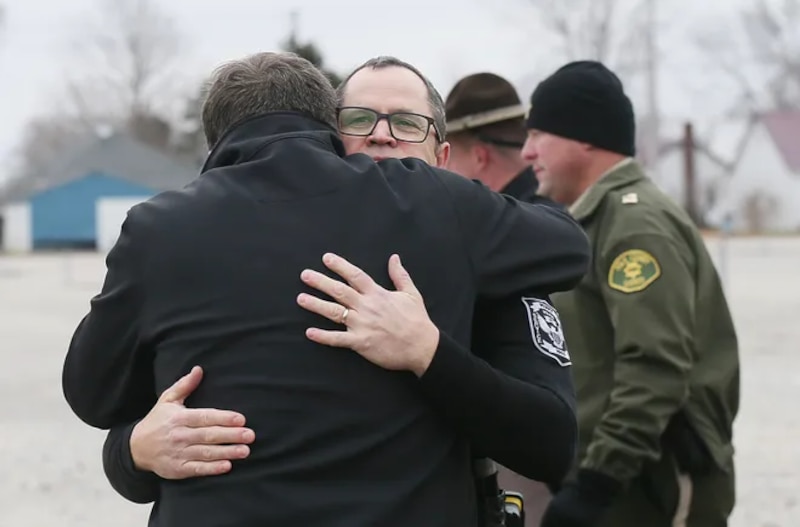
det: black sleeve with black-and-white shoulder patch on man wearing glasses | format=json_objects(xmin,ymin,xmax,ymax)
[{"xmin": 420, "ymin": 297, "xmax": 578, "ymax": 483}]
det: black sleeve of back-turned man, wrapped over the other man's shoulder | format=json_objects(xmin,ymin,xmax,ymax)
[{"xmin": 441, "ymin": 174, "xmax": 591, "ymax": 298}]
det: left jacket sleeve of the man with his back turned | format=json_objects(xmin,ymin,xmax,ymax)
[{"xmin": 62, "ymin": 207, "xmax": 156, "ymax": 429}]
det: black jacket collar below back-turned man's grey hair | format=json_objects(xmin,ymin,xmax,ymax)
[{"xmin": 201, "ymin": 112, "xmax": 345, "ymax": 172}]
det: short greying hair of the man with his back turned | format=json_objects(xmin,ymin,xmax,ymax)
[{"xmin": 202, "ymin": 52, "xmax": 336, "ymax": 148}]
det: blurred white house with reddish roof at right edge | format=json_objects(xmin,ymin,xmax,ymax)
[{"xmin": 714, "ymin": 111, "xmax": 800, "ymax": 232}]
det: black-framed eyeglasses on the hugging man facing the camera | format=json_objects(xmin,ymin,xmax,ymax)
[{"xmin": 338, "ymin": 106, "xmax": 439, "ymax": 143}]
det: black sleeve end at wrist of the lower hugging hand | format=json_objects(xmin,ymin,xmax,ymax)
[{"xmin": 103, "ymin": 421, "xmax": 161, "ymax": 503}]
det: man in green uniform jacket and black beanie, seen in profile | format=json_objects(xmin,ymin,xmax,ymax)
[{"xmin": 523, "ymin": 61, "xmax": 739, "ymax": 527}]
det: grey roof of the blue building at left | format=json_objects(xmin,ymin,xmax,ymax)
[{"xmin": 0, "ymin": 133, "xmax": 199, "ymax": 202}]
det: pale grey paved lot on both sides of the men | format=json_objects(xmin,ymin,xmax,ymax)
[{"xmin": 0, "ymin": 238, "xmax": 800, "ymax": 527}]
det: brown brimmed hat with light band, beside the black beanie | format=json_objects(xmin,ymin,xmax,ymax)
[{"xmin": 445, "ymin": 73, "xmax": 527, "ymax": 142}]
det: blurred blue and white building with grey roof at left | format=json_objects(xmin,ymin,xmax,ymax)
[{"xmin": 0, "ymin": 134, "xmax": 199, "ymax": 252}]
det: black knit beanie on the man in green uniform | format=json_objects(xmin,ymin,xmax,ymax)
[{"xmin": 527, "ymin": 60, "xmax": 636, "ymax": 157}]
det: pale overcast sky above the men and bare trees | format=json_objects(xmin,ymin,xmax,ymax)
[{"xmin": 0, "ymin": 0, "xmax": 748, "ymax": 179}]
